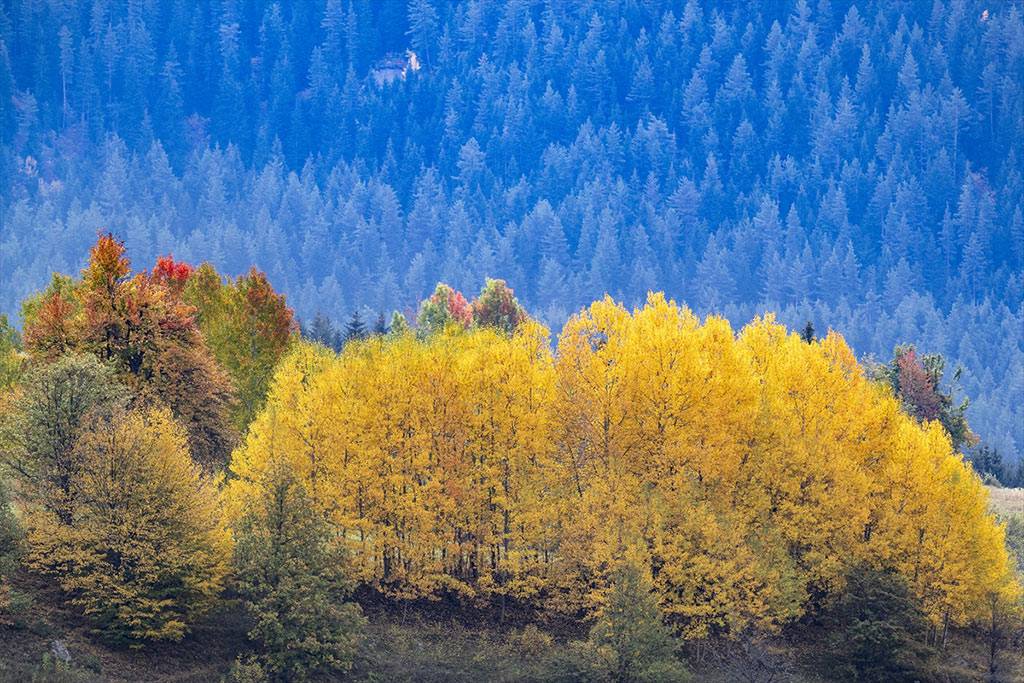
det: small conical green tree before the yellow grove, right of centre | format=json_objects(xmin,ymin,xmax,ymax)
[{"xmin": 590, "ymin": 562, "xmax": 689, "ymax": 682}]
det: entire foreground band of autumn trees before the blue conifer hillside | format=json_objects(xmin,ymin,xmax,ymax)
[{"xmin": 0, "ymin": 233, "xmax": 1024, "ymax": 682}]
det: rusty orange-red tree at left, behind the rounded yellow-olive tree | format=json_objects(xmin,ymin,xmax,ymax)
[{"xmin": 25, "ymin": 234, "xmax": 237, "ymax": 467}]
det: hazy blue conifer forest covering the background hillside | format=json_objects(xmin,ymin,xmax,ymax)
[{"xmin": 0, "ymin": 0, "xmax": 1024, "ymax": 461}]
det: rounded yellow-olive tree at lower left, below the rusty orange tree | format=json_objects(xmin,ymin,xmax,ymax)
[{"xmin": 27, "ymin": 409, "xmax": 229, "ymax": 647}]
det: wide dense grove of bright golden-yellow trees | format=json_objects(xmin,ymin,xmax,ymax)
[{"xmin": 227, "ymin": 288, "xmax": 1019, "ymax": 638}]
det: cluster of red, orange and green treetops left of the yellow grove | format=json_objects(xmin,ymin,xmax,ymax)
[{"xmin": 17, "ymin": 234, "xmax": 295, "ymax": 468}]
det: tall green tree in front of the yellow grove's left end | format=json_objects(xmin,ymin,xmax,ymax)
[{"xmin": 234, "ymin": 462, "xmax": 365, "ymax": 681}]
